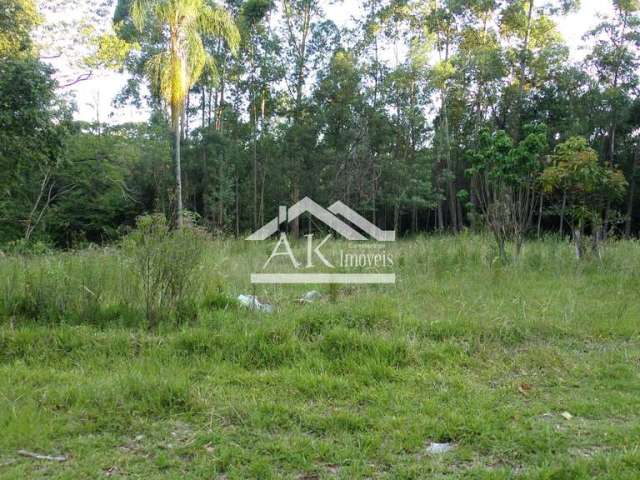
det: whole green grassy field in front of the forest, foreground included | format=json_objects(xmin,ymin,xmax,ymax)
[{"xmin": 0, "ymin": 236, "xmax": 640, "ymax": 479}]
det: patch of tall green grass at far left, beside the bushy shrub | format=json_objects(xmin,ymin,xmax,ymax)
[{"xmin": 0, "ymin": 248, "xmax": 141, "ymax": 328}]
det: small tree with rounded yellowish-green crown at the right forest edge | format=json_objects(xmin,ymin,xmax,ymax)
[{"xmin": 542, "ymin": 137, "xmax": 627, "ymax": 259}]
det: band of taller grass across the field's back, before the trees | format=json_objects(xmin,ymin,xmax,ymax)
[{"xmin": 0, "ymin": 235, "xmax": 640, "ymax": 331}]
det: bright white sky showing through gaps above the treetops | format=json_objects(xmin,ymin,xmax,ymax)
[{"xmin": 45, "ymin": 0, "xmax": 612, "ymax": 123}]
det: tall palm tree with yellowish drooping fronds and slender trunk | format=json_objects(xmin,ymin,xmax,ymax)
[{"xmin": 131, "ymin": 0, "xmax": 240, "ymax": 228}]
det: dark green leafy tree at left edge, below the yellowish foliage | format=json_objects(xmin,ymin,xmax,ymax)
[{"xmin": 0, "ymin": 58, "xmax": 70, "ymax": 240}]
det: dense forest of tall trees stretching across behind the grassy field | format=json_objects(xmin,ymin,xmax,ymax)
[{"xmin": 0, "ymin": 0, "xmax": 640, "ymax": 248}]
